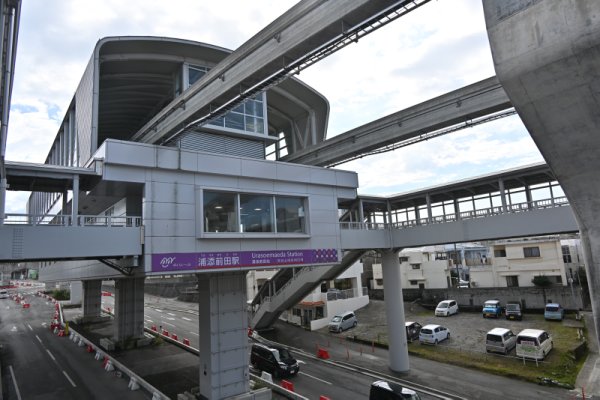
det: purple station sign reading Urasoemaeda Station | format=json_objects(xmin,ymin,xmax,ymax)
[{"xmin": 152, "ymin": 249, "xmax": 339, "ymax": 272}]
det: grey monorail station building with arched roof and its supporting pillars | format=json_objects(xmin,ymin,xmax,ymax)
[{"xmin": 23, "ymin": 37, "xmax": 358, "ymax": 398}]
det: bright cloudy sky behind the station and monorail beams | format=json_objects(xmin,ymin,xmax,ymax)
[{"xmin": 6, "ymin": 0, "xmax": 543, "ymax": 213}]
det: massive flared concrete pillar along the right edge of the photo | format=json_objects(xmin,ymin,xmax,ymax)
[{"xmin": 483, "ymin": 0, "xmax": 600, "ymax": 346}]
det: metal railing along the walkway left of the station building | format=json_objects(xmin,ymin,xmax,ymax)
[{"xmin": 4, "ymin": 214, "xmax": 142, "ymax": 227}]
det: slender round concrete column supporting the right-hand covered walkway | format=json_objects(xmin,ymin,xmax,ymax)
[{"xmin": 382, "ymin": 250, "xmax": 409, "ymax": 372}]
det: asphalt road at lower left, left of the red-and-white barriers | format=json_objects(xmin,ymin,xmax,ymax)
[{"xmin": 0, "ymin": 288, "xmax": 151, "ymax": 400}]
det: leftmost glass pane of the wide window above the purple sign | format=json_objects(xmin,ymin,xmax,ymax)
[{"xmin": 203, "ymin": 191, "xmax": 238, "ymax": 232}]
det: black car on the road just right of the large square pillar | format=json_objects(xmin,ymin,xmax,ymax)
[{"xmin": 250, "ymin": 344, "xmax": 300, "ymax": 378}]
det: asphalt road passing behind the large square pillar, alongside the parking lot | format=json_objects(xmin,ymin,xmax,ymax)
[{"xmin": 104, "ymin": 296, "xmax": 574, "ymax": 400}]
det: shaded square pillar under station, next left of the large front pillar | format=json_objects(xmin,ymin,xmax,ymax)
[{"xmin": 113, "ymin": 278, "xmax": 144, "ymax": 342}]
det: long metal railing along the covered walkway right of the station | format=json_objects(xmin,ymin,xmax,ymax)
[{"xmin": 340, "ymin": 197, "xmax": 569, "ymax": 230}]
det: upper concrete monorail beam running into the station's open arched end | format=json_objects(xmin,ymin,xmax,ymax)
[{"xmin": 131, "ymin": 0, "xmax": 429, "ymax": 144}]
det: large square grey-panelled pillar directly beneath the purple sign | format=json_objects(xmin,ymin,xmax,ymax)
[{"xmin": 198, "ymin": 272, "xmax": 249, "ymax": 400}]
